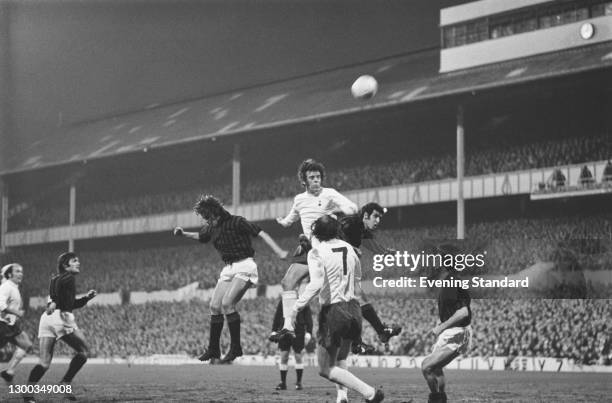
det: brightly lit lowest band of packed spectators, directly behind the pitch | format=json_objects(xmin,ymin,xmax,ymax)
[{"xmin": 3, "ymin": 296, "xmax": 612, "ymax": 365}]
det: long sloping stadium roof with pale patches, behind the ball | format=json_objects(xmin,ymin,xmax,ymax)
[{"xmin": 0, "ymin": 42, "xmax": 612, "ymax": 173}]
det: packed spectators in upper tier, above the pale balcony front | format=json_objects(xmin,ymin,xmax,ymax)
[{"xmin": 8, "ymin": 136, "xmax": 612, "ymax": 231}]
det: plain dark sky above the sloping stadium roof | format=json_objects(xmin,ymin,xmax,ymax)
[{"xmin": 0, "ymin": 0, "xmax": 466, "ymax": 155}]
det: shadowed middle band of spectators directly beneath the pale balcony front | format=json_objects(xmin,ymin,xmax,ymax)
[{"xmin": 0, "ymin": 215, "xmax": 612, "ymax": 296}]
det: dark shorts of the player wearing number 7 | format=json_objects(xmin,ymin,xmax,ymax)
[{"xmin": 317, "ymin": 299, "xmax": 361, "ymax": 348}]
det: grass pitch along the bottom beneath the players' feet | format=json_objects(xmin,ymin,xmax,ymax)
[{"xmin": 0, "ymin": 364, "xmax": 612, "ymax": 403}]
